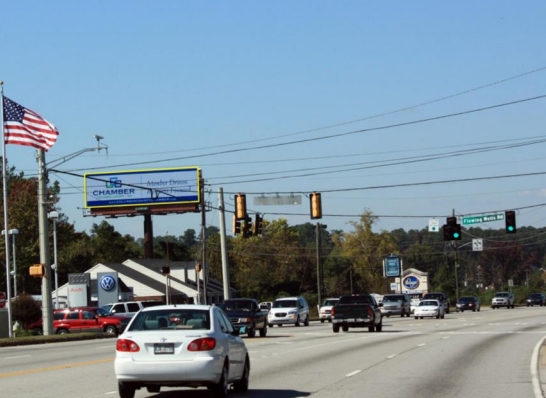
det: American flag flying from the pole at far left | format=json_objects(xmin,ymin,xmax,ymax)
[{"xmin": 3, "ymin": 97, "xmax": 59, "ymax": 151}]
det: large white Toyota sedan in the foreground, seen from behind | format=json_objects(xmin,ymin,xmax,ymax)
[{"xmin": 114, "ymin": 304, "xmax": 250, "ymax": 398}]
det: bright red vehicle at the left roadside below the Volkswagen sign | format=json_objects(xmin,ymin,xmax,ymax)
[{"xmin": 53, "ymin": 307, "xmax": 131, "ymax": 336}]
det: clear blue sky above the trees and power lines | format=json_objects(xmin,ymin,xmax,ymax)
[{"xmin": 0, "ymin": 0, "xmax": 546, "ymax": 238}]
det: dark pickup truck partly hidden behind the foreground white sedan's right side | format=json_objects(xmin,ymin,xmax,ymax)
[{"xmin": 219, "ymin": 298, "xmax": 267, "ymax": 337}]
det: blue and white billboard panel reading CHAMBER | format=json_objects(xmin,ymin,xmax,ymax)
[{"xmin": 83, "ymin": 167, "xmax": 200, "ymax": 209}]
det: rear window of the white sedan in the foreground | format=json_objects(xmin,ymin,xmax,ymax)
[{"xmin": 129, "ymin": 308, "xmax": 210, "ymax": 332}]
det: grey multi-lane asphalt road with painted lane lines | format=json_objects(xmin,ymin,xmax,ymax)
[{"xmin": 0, "ymin": 307, "xmax": 546, "ymax": 398}]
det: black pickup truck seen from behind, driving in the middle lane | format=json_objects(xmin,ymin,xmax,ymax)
[{"xmin": 332, "ymin": 294, "xmax": 383, "ymax": 333}]
